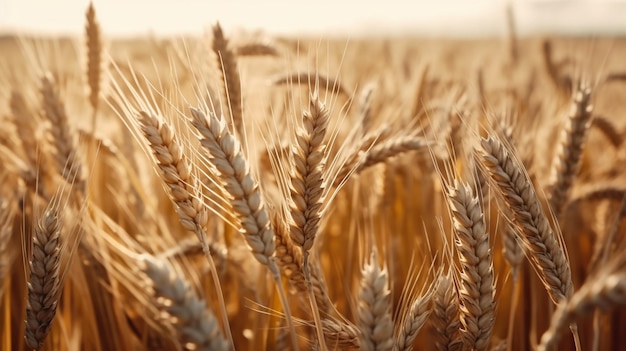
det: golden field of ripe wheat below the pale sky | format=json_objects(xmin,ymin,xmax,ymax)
[{"xmin": 0, "ymin": 5, "xmax": 626, "ymax": 350}]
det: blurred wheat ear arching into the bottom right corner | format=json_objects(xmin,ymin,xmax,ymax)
[{"xmin": 537, "ymin": 273, "xmax": 626, "ymax": 351}]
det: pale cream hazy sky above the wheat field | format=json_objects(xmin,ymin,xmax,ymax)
[{"xmin": 0, "ymin": 0, "xmax": 626, "ymax": 36}]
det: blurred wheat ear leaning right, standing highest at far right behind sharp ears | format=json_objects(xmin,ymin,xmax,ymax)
[{"xmin": 549, "ymin": 83, "xmax": 593, "ymax": 219}]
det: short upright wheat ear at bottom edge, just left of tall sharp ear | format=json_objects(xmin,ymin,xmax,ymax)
[{"xmin": 431, "ymin": 270, "xmax": 463, "ymax": 351}]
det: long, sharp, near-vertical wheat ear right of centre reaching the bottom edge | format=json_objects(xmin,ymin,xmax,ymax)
[{"xmin": 446, "ymin": 180, "xmax": 495, "ymax": 350}]
